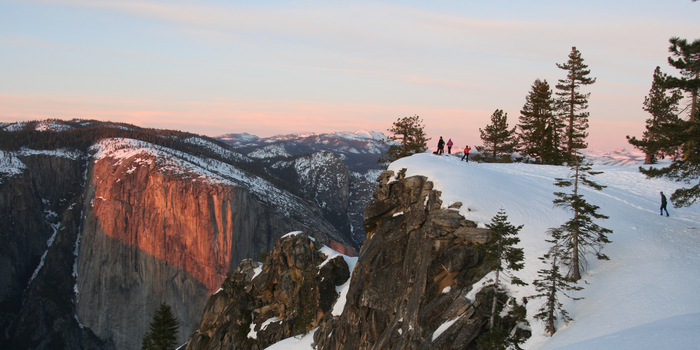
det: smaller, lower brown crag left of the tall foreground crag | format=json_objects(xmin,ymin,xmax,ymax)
[{"xmin": 185, "ymin": 233, "xmax": 350, "ymax": 350}]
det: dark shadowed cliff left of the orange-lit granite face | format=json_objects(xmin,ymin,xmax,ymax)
[{"xmin": 0, "ymin": 152, "xmax": 114, "ymax": 349}]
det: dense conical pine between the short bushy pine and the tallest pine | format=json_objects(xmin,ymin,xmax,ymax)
[{"xmin": 518, "ymin": 79, "xmax": 564, "ymax": 164}]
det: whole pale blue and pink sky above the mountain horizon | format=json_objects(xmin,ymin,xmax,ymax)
[{"xmin": 0, "ymin": 0, "xmax": 700, "ymax": 150}]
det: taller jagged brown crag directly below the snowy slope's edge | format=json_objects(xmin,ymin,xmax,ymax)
[{"xmin": 314, "ymin": 171, "xmax": 487, "ymax": 349}]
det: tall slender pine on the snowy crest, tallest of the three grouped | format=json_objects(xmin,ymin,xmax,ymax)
[{"xmin": 556, "ymin": 46, "xmax": 596, "ymax": 158}]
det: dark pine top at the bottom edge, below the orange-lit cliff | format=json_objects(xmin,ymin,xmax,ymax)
[{"xmin": 141, "ymin": 303, "xmax": 180, "ymax": 350}]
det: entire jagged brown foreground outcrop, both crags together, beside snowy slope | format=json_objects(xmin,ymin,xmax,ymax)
[{"xmin": 179, "ymin": 168, "xmax": 504, "ymax": 350}]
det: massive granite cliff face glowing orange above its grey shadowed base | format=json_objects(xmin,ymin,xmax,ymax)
[{"xmin": 77, "ymin": 143, "xmax": 348, "ymax": 349}]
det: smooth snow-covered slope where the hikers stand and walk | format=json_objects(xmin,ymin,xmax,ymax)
[{"xmin": 262, "ymin": 152, "xmax": 700, "ymax": 350}]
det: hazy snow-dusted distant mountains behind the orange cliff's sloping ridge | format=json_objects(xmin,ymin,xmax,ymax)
[{"xmin": 217, "ymin": 129, "xmax": 393, "ymax": 248}]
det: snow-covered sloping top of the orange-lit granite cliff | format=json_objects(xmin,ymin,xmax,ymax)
[{"xmin": 90, "ymin": 138, "xmax": 318, "ymax": 216}]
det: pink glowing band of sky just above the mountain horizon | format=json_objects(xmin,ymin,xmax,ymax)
[{"xmin": 0, "ymin": 94, "xmax": 644, "ymax": 150}]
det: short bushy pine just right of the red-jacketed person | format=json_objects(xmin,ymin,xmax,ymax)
[{"xmin": 477, "ymin": 109, "xmax": 518, "ymax": 162}]
